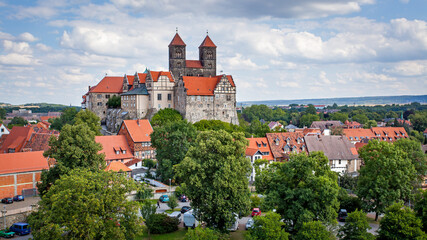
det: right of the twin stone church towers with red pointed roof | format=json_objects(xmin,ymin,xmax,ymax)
[{"xmin": 199, "ymin": 35, "xmax": 216, "ymax": 77}]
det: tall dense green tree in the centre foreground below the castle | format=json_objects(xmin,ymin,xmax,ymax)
[{"xmin": 175, "ymin": 130, "xmax": 251, "ymax": 231}]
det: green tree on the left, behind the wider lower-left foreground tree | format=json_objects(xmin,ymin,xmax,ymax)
[{"xmin": 37, "ymin": 124, "xmax": 105, "ymax": 195}]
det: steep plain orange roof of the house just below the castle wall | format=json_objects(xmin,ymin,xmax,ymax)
[{"xmin": 122, "ymin": 119, "xmax": 153, "ymax": 142}]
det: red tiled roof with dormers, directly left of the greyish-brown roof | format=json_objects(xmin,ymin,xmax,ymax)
[{"xmin": 266, "ymin": 132, "xmax": 307, "ymax": 160}]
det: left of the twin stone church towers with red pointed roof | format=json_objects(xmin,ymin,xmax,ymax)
[{"xmin": 169, "ymin": 31, "xmax": 186, "ymax": 79}]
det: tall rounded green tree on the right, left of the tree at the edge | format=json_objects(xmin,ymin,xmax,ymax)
[{"xmin": 356, "ymin": 140, "xmax": 416, "ymax": 220}]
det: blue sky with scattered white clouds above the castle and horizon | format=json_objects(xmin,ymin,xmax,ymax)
[{"xmin": 0, "ymin": 0, "xmax": 427, "ymax": 106}]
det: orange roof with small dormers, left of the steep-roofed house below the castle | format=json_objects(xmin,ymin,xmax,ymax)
[{"xmin": 95, "ymin": 135, "xmax": 133, "ymax": 161}]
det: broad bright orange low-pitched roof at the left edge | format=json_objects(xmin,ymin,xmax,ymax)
[{"xmin": 0, "ymin": 151, "xmax": 49, "ymax": 174}]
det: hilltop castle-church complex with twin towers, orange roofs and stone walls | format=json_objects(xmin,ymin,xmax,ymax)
[{"xmin": 82, "ymin": 32, "xmax": 238, "ymax": 131}]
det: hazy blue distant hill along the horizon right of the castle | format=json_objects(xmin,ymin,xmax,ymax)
[{"xmin": 237, "ymin": 95, "xmax": 427, "ymax": 106}]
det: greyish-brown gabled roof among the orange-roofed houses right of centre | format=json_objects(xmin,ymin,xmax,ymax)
[{"xmin": 305, "ymin": 135, "xmax": 358, "ymax": 160}]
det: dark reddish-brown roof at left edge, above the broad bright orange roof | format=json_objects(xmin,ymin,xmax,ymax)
[{"xmin": 0, "ymin": 126, "xmax": 34, "ymax": 153}]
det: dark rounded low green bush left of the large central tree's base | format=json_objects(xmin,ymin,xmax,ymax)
[{"xmin": 146, "ymin": 213, "xmax": 179, "ymax": 234}]
